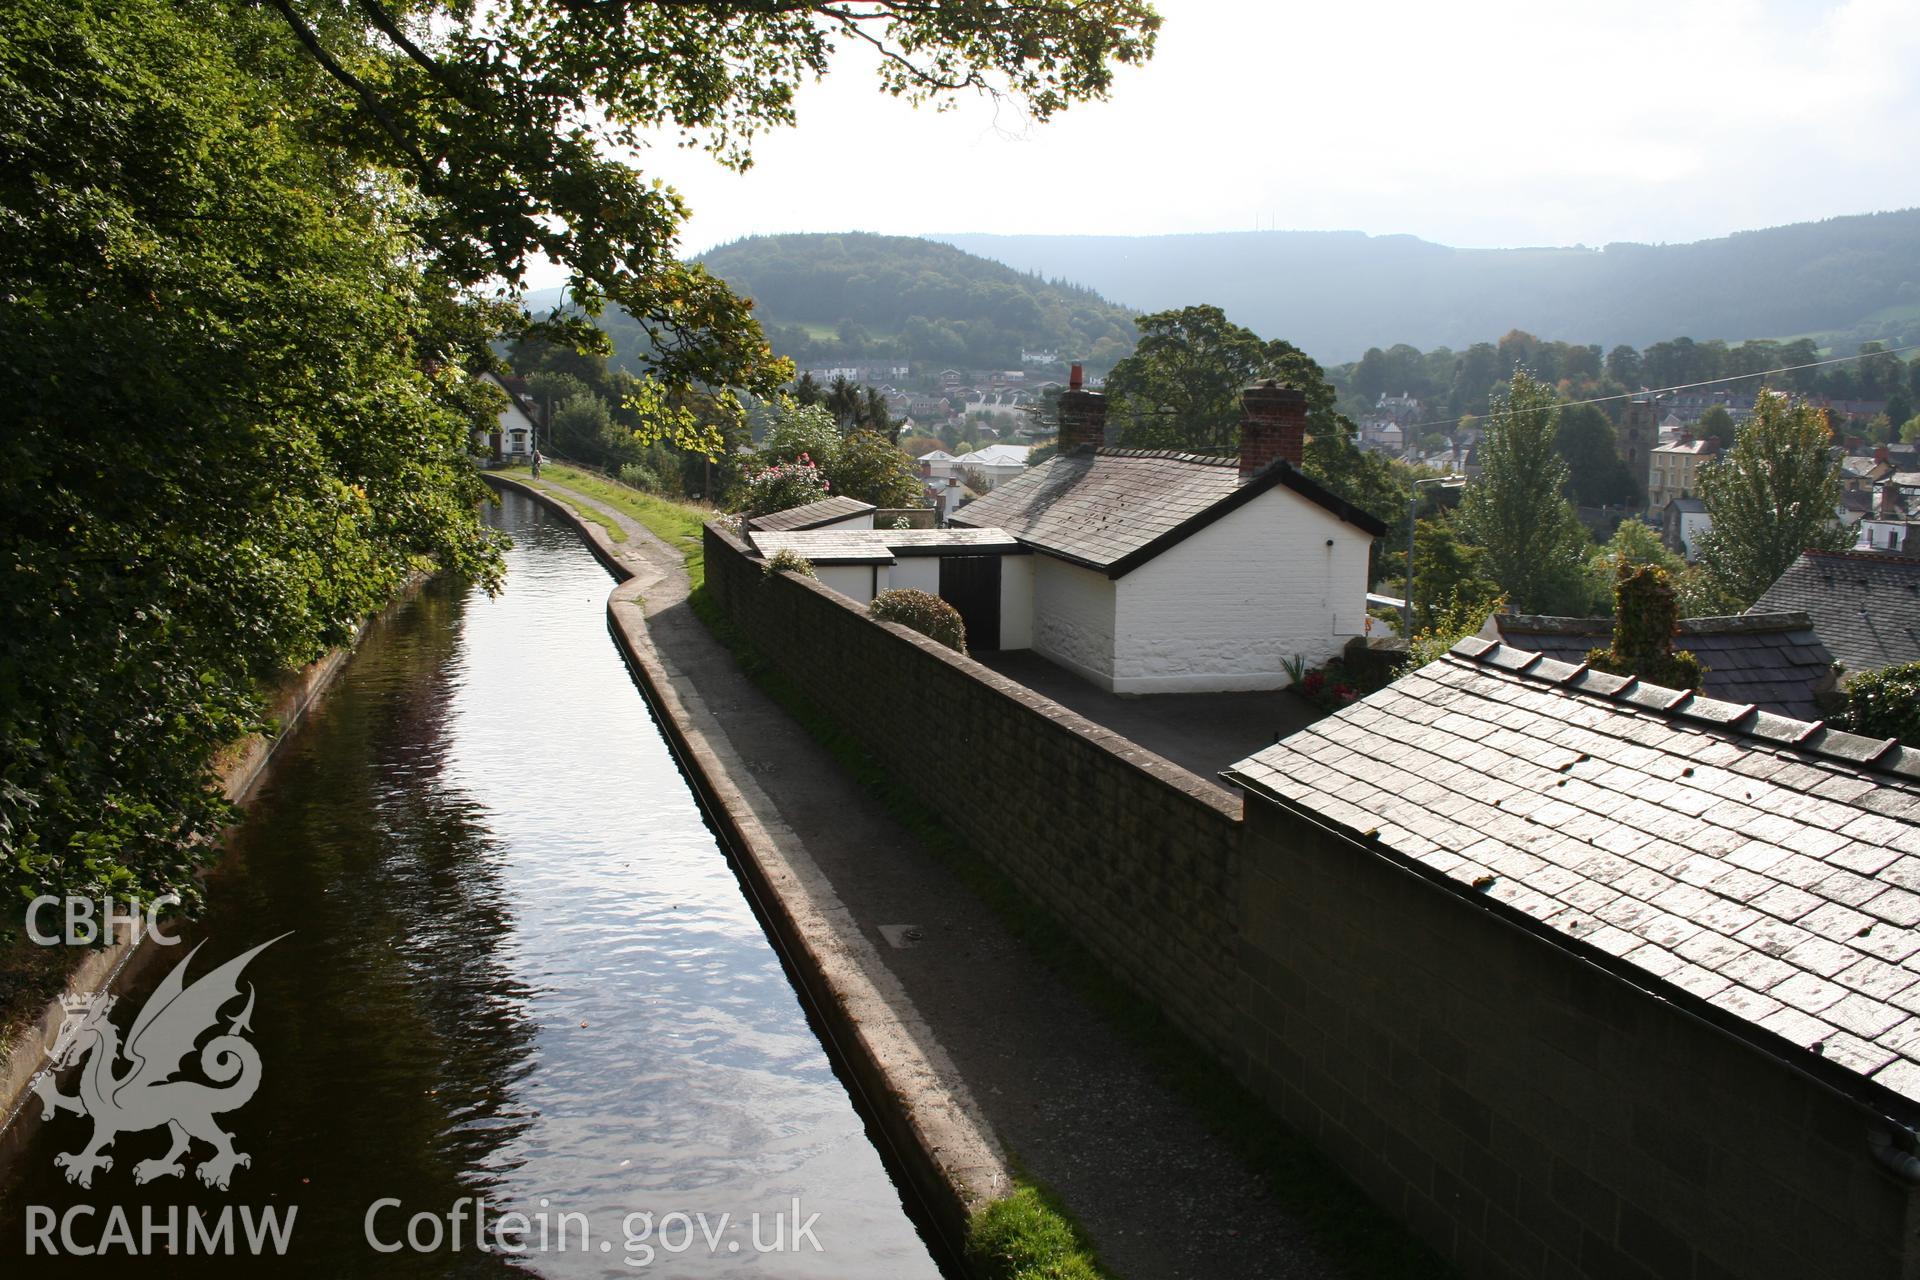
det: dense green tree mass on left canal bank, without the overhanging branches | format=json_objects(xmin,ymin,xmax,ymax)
[{"xmin": 0, "ymin": 0, "xmax": 499, "ymax": 898}]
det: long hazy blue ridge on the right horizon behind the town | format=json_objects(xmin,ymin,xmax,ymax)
[{"xmin": 939, "ymin": 209, "xmax": 1920, "ymax": 363}]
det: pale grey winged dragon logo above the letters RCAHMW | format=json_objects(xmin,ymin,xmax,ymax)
[{"xmin": 33, "ymin": 933, "xmax": 286, "ymax": 1192}]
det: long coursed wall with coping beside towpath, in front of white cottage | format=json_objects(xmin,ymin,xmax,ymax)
[{"xmin": 707, "ymin": 526, "xmax": 1240, "ymax": 1055}]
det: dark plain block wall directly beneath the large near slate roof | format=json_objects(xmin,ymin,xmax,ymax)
[{"xmin": 1238, "ymin": 802, "xmax": 1920, "ymax": 1280}]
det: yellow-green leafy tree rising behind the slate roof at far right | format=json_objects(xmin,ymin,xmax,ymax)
[{"xmin": 1699, "ymin": 391, "xmax": 1853, "ymax": 608}]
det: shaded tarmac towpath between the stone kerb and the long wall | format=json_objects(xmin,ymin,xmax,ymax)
[{"xmin": 503, "ymin": 478, "xmax": 1344, "ymax": 1280}]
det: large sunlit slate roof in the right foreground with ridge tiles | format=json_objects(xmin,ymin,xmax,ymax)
[{"xmin": 1227, "ymin": 637, "xmax": 1920, "ymax": 1115}]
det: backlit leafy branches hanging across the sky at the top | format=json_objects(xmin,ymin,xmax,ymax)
[{"xmin": 263, "ymin": 0, "xmax": 1160, "ymax": 447}]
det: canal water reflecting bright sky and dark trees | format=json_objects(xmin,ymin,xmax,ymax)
[{"xmin": 0, "ymin": 495, "xmax": 939, "ymax": 1280}]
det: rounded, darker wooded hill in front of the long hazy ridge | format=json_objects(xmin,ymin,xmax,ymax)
[{"xmin": 695, "ymin": 232, "xmax": 1135, "ymax": 370}]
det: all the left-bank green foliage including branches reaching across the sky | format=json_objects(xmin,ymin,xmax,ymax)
[{"xmin": 0, "ymin": 0, "xmax": 1158, "ymax": 896}]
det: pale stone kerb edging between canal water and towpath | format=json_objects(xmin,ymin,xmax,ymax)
[{"xmin": 488, "ymin": 476, "xmax": 1014, "ymax": 1259}]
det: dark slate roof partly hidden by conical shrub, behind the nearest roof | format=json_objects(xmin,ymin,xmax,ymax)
[{"xmin": 1480, "ymin": 612, "xmax": 1834, "ymax": 720}]
